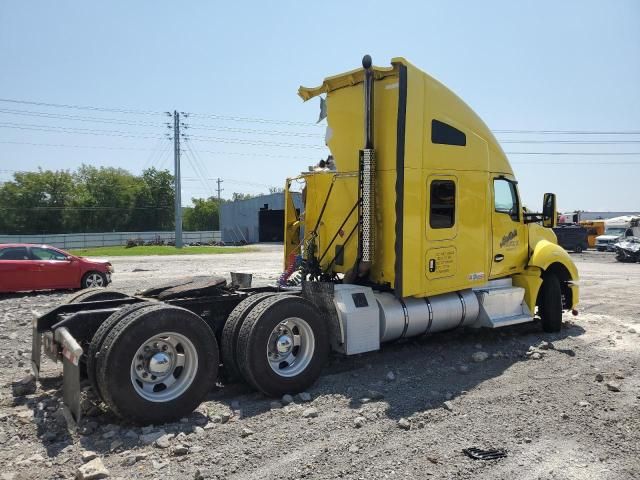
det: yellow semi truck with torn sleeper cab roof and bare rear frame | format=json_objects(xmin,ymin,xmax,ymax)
[{"xmin": 32, "ymin": 56, "xmax": 578, "ymax": 423}]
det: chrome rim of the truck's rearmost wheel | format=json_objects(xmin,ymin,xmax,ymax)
[{"xmin": 131, "ymin": 332, "xmax": 198, "ymax": 402}]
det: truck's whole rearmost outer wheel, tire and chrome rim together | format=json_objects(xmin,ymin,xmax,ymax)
[{"xmin": 96, "ymin": 305, "xmax": 219, "ymax": 424}]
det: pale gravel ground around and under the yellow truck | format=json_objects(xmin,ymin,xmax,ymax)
[{"xmin": 0, "ymin": 246, "xmax": 640, "ymax": 480}]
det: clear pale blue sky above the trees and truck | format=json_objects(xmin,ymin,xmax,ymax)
[{"xmin": 0, "ymin": 0, "xmax": 640, "ymax": 210}]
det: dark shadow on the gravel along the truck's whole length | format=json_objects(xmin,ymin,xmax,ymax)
[{"xmin": 21, "ymin": 322, "xmax": 584, "ymax": 456}]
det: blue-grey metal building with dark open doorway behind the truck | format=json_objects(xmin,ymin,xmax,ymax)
[{"xmin": 220, "ymin": 193, "xmax": 302, "ymax": 243}]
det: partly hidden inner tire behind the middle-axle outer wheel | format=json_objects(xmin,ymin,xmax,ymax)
[{"xmin": 220, "ymin": 292, "xmax": 276, "ymax": 383}]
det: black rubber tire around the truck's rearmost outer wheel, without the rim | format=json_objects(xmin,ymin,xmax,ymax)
[{"xmin": 96, "ymin": 305, "xmax": 219, "ymax": 424}]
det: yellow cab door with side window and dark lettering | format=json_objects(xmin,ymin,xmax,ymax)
[{"xmin": 491, "ymin": 176, "xmax": 529, "ymax": 278}]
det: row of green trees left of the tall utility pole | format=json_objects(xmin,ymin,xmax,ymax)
[{"xmin": 0, "ymin": 165, "xmax": 175, "ymax": 234}]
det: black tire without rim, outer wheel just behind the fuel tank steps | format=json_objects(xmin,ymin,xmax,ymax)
[{"xmin": 237, "ymin": 295, "xmax": 330, "ymax": 397}]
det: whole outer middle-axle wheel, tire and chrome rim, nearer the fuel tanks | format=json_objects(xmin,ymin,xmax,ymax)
[{"xmin": 237, "ymin": 295, "xmax": 329, "ymax": 397}]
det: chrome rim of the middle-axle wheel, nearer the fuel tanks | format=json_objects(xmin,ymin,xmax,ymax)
[{"xmin": 267, "ymin": 317, "xmax": 315, "ymax": 377}]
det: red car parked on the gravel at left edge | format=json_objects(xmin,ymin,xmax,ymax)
[{"xmin": 0, "ymin": 243, "xmax": 113, "ymax": 292}]
